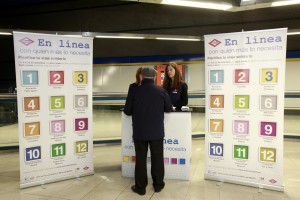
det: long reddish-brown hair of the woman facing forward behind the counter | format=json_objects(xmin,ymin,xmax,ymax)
[{"xmin": 163, "ymin": 62, "xmax": 184, "ymax": 90}]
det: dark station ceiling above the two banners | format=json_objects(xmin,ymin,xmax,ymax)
[{"xmin": 0, "ymin": 0, "xmax": 300, "ymax": 57}]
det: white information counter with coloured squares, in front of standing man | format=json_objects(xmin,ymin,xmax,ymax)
[{"xmin": 122, "ymin": 111, "xmax": 192, "ymax": 180}]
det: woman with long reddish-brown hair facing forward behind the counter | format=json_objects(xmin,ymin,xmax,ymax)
[{"xmin": 163, "ymin": 62, "xmax": 188, "ymax": 109}]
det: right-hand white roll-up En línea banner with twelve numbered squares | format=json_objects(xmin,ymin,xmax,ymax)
[{"xmin": 205, "ymin": 28, "xmax": 287, "ymax": 191}]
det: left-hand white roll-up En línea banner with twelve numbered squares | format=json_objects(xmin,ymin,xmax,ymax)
[{"xmin": 13, "ymin": 32, "xmax": 94, "ymax": 188}]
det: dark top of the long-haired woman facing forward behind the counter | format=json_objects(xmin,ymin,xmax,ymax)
[{"xmin": 168, "ymin": 83, "xmax": 188, "ymax": 109}]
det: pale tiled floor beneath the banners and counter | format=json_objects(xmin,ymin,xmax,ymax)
[{"xmin": 0, "ymin": 139, "xmax": 300, "ymax": 200}]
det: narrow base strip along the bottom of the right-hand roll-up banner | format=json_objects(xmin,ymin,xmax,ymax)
[{"xmin": 204, "ymin": 174, "xmax": 284, "ymax": 192}]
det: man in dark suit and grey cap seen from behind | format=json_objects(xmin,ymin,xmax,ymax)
[{"xmin": 124, "ymin": 68, "xmax": 173, "ymax": 195}]
